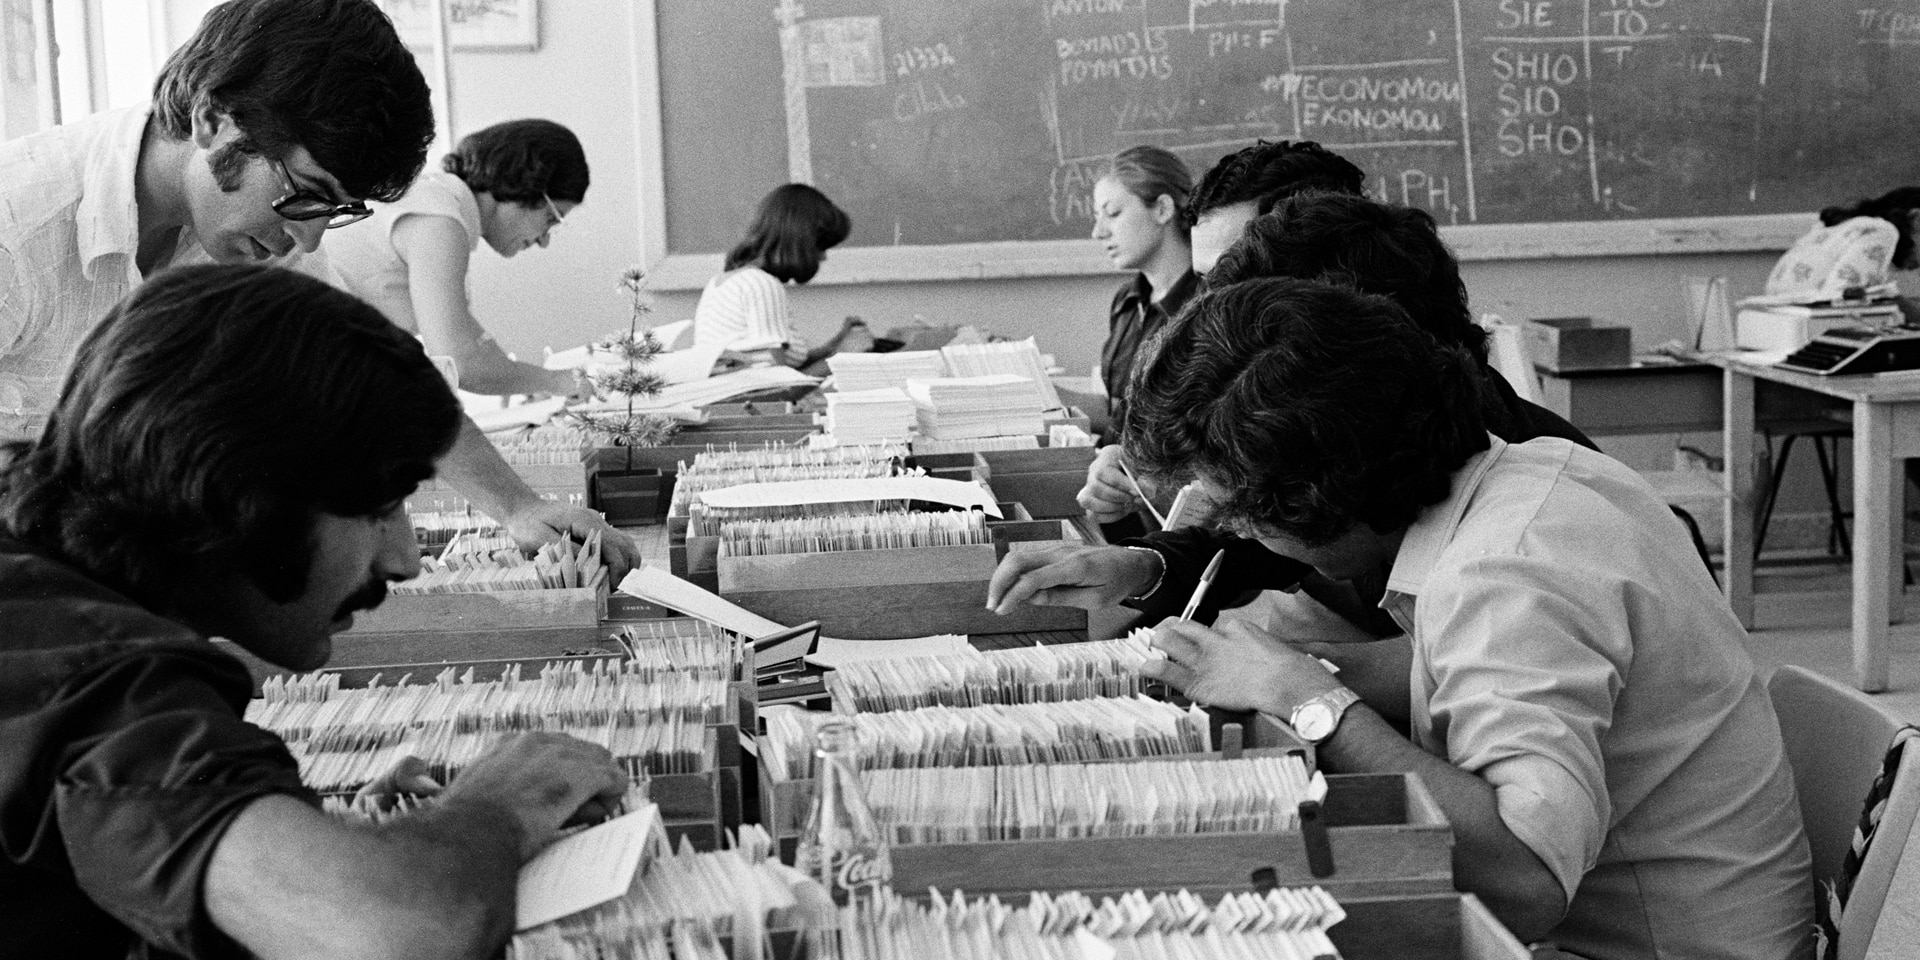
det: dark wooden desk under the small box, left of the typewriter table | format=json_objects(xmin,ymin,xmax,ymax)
[{"xmin": 1536, "ymin": 359, "xmax": 1720, "ymax": 436}]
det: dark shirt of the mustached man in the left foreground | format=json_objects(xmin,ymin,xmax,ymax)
[{"xmin": 0, "ymin": 536, "xmax": 317, "ymax": 960}]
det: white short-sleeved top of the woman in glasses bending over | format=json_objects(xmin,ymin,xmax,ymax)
[{"xmin": 324, "ymin": 171, "xmax": 480, "ymax": 334}]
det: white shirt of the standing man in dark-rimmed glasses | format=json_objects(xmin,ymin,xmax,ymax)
[{"xmin": 0, "ymin": 106, "xmax": 204, "ymax": 440}]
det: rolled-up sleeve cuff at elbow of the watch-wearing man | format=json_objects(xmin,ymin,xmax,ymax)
[{"xmin": 1480, "ymin": 755, "xmax": 1607, "ymax": 902}]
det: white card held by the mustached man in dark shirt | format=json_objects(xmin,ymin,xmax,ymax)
[{"xmin": 513, "ymin": 803, "xmax": 666, "ymax": 931}]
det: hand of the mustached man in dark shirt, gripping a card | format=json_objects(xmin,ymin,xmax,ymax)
[{"xmin": 445, "ymin": 733, "xmax": 626, "ymax": 860}]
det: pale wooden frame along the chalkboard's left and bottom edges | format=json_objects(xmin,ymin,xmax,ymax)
[{"xmin": 632, "ymin": 0, "xmax": 1814, "ymax": 290}]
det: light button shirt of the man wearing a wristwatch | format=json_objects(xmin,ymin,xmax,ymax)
[{"xmin": 1380, "ymin": 438, "xmax": 1812, "ymax": 960}]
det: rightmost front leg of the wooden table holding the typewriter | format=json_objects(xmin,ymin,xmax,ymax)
[{"xmin": 1853, "ymin": 401, "xmax": 1901, "ymax": 693}]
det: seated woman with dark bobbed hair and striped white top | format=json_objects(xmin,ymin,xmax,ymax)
[{"xmin": 693, "ymin": 182, "xmax": 872, "ymax": 367}]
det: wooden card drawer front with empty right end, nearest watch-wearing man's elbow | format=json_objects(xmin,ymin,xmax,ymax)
[{"xmin": 891, "ymin": 774, "xmax": 1453, "ymax": 902}]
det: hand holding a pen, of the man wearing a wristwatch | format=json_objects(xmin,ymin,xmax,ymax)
[{"xmin": 1140, "ymin": 618, "xmax": 1342, "ymax": 720}]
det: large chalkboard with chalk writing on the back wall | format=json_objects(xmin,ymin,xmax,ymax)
[{"xmin": 655, "ymin": 0, "xmax": 1920, "ymax": 280}]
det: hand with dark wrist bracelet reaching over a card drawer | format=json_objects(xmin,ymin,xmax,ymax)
[{"xmin": 987, "ymin": 545, "xmax": 1164, "ymax": 612}]
